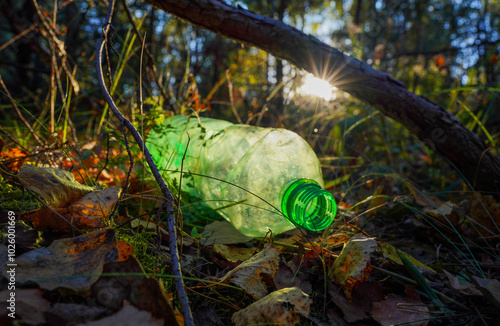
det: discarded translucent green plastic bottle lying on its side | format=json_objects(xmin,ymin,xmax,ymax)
[{"xmin": 146, "ymin": 115, "xmax": 337, "ymax": 237}]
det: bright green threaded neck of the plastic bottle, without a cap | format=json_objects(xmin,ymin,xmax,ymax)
[{"xmin": 281, "ymin": 179, "xmax": 337, "ymax": 231}]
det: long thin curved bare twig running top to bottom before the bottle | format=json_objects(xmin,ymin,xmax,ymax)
[{"xmin": 96, "ymin": 0, "xmax": 194, "ymax": 326}]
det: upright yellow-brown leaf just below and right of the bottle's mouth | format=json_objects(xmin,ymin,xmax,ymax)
[{"xmin": 328, "ymin": 236, "xmax": 377, "ymax": 299}]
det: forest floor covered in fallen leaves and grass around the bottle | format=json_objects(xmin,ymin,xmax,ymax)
[{"xmin": 0, "ymin": 134, "xmax": 500, "ymax": 326}]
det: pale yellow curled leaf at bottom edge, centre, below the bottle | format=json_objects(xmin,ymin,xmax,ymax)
[{"xmin": 231, "ymin": 287, "xmax": 312, "ymax": 326}]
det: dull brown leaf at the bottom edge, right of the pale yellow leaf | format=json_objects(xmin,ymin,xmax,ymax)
[{"xmin": 371, "ymin": 286, "xmax": 431, "ymax": 326}]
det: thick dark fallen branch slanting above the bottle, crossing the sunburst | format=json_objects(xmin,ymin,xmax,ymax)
[{"xmin": 146, "ymin": 0, "xmax": 500, "ymax": 195}]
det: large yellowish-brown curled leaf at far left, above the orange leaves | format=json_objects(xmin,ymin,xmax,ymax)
[{"xmin": 17, "ymin": 164, "xmax": 94, "ymax": 208}]
